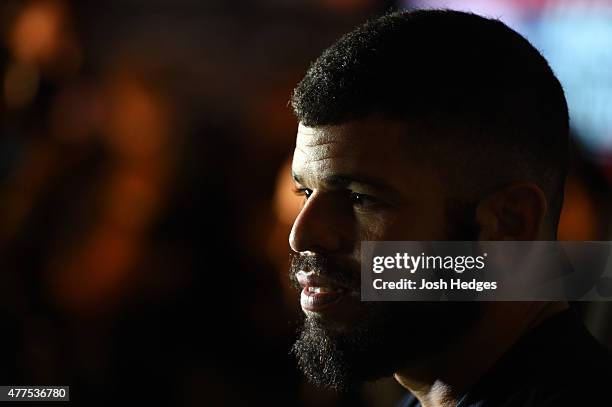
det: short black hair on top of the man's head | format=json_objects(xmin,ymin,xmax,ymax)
[{"xmin": 291, "ymin": 10, "xmax": 569, "ymax": 230}]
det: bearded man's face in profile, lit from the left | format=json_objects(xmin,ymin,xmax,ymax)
[{"xmin": 289, "ymin": 116, "xmax": 476, "ymax": 388}]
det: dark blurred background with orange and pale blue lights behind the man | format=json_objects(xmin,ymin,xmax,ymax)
[{"xmin": 0, "ymin": 0, "xmax": 612, "ymax": 407}]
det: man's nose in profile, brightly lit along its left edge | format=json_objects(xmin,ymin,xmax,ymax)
[{"xmin": 289, "ymin": 192, "xmax": 346, "ymax": 253}]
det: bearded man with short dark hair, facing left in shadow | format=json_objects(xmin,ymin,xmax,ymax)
[{"xmin": 289, "ymin": 10, "xmax": 612, "ymax": 407}]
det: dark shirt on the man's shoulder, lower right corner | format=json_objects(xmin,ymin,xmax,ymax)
[{"xmin": 398, "ymin": 310, "xmax": 612, "ymax": 407}]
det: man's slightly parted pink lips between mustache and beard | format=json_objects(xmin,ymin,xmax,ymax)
[{"xmin": 296, "ymin": 271, "xmax": 349, "ymax": 312}]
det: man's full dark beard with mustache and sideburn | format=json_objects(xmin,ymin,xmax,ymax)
[{"xmin": 290, "ymin": 200, "xmax": 481, "ymax": 392}]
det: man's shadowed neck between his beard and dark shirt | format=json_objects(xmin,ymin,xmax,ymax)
[{"xmin": 394, "ymin": 302, "xmax": 568, "ymax": 407}]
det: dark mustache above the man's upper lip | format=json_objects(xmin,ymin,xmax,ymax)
[{"xmin": 289, "ymin": 253, "xmax": 361, "ymax": 291}]
